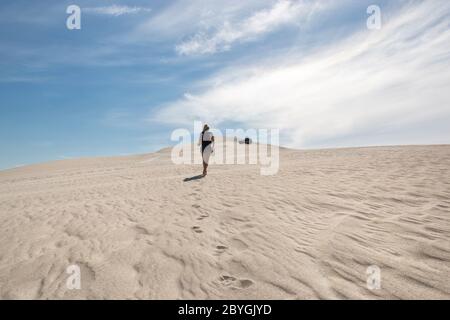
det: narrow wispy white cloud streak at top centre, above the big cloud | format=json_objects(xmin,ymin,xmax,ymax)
[{"xmin": 176, "ymin": 0, "xmax": 325, "ymax": 55}]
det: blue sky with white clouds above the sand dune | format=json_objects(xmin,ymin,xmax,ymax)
[{"xmin": 0, "ymin": 0, "xmax": 450, "ymax": 169}]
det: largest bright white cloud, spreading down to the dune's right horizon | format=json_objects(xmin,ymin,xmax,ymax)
[{"xmin": 152, "ymin": 0, "xmax": 450, "ymax": 147}]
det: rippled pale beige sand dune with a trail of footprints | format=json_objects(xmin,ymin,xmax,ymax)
[{"xmin": 0, "ymin": 146, "xmax": 450, "ymax": 299}]
